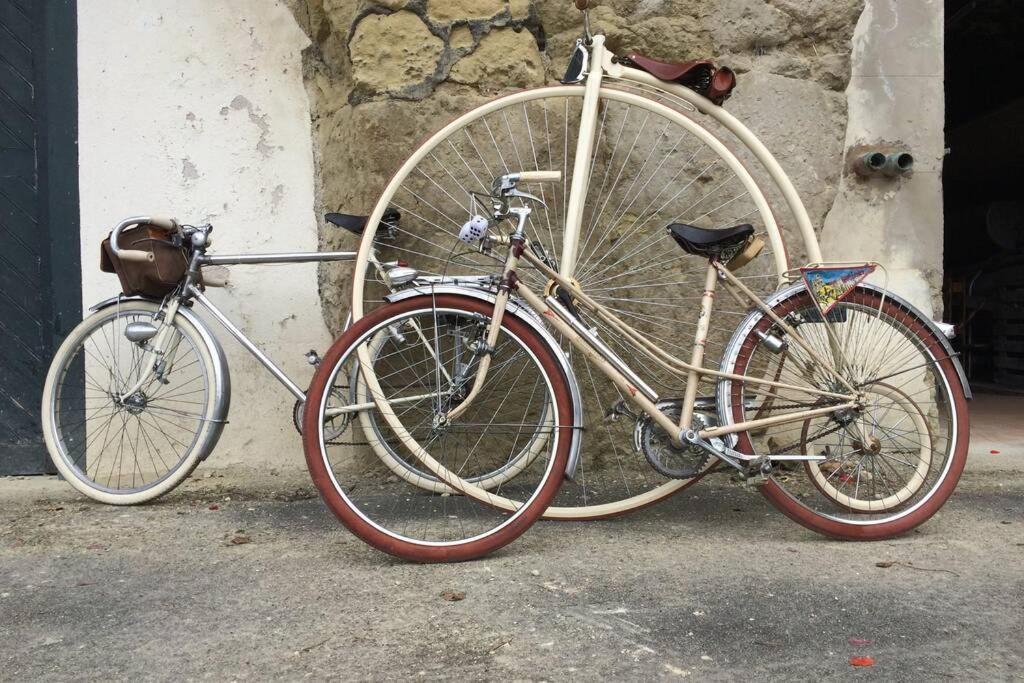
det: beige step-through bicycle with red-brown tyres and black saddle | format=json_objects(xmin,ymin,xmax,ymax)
[{"xmin": 303, "ymin": 171, "xmax": 970, "ymax": 561}]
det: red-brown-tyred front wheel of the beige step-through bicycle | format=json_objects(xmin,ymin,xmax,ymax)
[{"xmin": 303, "ymin": 295, "xmax": 572, "ymax": 562}]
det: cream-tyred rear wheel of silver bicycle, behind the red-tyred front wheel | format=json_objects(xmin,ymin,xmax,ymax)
[{"xmin": 356, "ymin": 330, "xmax": 550, "ymax": 494}]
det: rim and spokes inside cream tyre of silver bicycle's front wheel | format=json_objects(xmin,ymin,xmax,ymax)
[{"xmin": 49, "ymin": 305, "xmax": 211, "ymax": 496}]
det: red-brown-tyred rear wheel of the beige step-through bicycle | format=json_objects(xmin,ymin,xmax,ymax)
[{"xmin": 720, "ymin": 288, "xmax": 970, "ymax": 541}]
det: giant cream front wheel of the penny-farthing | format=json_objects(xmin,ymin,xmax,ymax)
[{"xmin": 352, "ymin": 86, "xmax": 787, "ymax": 519}]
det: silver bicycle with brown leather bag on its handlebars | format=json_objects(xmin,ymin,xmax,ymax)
[{"xmin": 42, "ymin": 216, "xmax": 385, "ymax": 505}]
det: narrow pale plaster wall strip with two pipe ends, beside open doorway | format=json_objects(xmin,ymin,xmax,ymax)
[{"xmin": 821, "ymin": 0, "xmax": 945, "ymax": 317}]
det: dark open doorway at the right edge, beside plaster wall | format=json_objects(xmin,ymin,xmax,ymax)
[{"xmin": 943, "ymin": 0, "xmax": 1024, "ymax": 392}]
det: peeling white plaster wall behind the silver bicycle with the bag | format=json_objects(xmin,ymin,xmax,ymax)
[{"xmin": 78, "ymin": 0, "xmax": 329, "ymax": 467}]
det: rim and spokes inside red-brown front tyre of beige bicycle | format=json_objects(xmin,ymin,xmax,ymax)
[{"xmin": 317, "ymin": 308, "xmax": 564, "ymax": 548}]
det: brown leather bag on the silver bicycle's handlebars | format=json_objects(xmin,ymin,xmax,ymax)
[{"xmin": 99, "ymin": 225, "xmax": 188, "ymax": 299}]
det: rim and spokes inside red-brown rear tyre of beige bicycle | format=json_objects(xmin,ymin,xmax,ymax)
[{"xmin": 725, "ymin": 291, "xmax": 962, "ymax": 527}]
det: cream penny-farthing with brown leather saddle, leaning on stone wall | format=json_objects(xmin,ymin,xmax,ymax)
[{"xmin": 352, "ymin": 2, "xmax": 821, "ymax": 511}]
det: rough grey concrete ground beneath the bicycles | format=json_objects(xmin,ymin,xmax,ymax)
[{"xmin": 0, "ymin": 396, "xmax": 1024, "ymax": 681}]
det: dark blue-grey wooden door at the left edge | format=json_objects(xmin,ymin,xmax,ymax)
[{"xmin": 0, "ymin": 0, "xmax": 82, "ymax": 474}]
